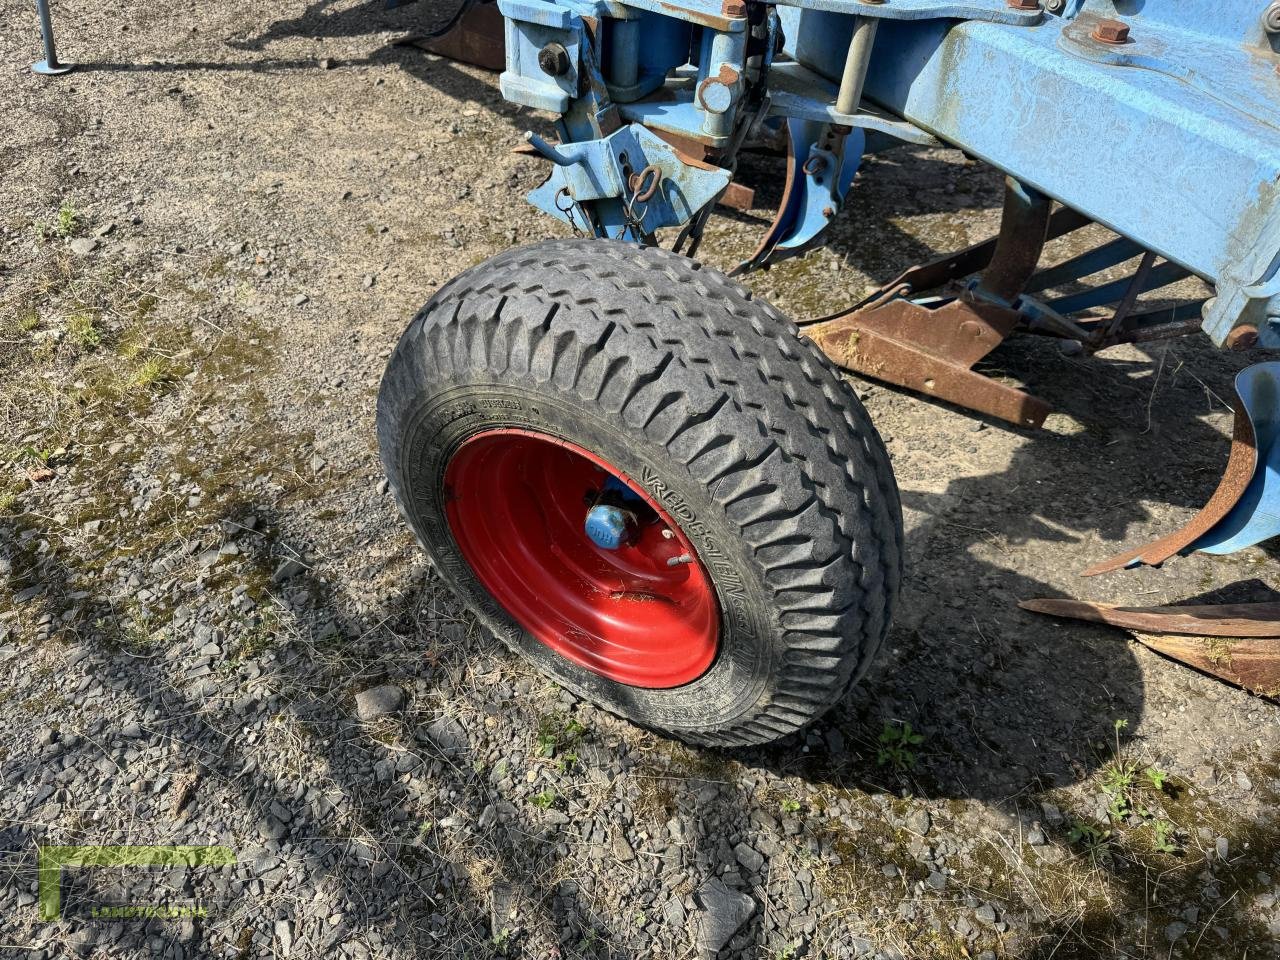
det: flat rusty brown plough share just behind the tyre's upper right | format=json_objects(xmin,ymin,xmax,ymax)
[{"xmin": 804, "ymin": 298, "xmax": 1050, "ymax": 426}]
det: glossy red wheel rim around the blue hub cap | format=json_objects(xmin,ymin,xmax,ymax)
[{"xmin": 444, "ymin": 430, "xmax": 719, "ymax": 689}]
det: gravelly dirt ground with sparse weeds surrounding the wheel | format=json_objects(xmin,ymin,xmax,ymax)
[{"xmin": 0, "ymin": 0, "xmax": 1280, "ymax": 960}]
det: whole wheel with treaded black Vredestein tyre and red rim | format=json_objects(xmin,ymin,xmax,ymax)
[{"xmin": 378, "ymin": 239, "xmax": 902, "ymax": 746}]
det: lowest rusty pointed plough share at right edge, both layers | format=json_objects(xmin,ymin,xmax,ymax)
[{"xmin": 1019, "ymin": 600, "xmax": 1280, "ymax": 699}]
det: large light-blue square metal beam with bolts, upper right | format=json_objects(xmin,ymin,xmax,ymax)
[{"xmin": 867, "ymin": 6, "xmax": 1280, "ymax": 342}]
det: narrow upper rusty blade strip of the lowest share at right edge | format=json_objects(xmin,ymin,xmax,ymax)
[{"xmin": 1018, "ymin": 599, "xmax": 1280, "ymax": 640}]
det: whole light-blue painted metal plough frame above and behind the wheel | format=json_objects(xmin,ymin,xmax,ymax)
[{"xmin": 499, "ymin": 0, "xmax": 1280, "ymax": 346}]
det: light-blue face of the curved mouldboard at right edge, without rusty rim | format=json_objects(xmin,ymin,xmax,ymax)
[{"xmin": 1185, "ymin": 361, "xmax": 1280, "ymax": 554}]
